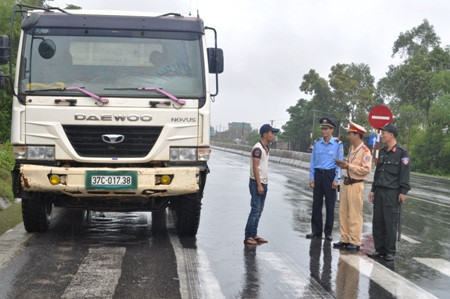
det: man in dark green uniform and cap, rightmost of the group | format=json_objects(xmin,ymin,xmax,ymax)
[{"xmin": 367, "ymin": 124, "xmax": 411, "ymax": 261}]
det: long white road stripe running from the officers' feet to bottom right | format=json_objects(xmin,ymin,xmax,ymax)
[{"xmin": 340, "ymin": 254, "xmax": 436, "ymax": 299}]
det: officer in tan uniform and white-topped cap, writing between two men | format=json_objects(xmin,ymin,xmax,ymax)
[{"xmin": 333, "ymin": 122, "xmax": 372, "ymax": 253}]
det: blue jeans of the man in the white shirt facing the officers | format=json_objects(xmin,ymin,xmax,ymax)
[{"xmin": 245, "ymin": 179, "xmax": 267, "ymax": 239}]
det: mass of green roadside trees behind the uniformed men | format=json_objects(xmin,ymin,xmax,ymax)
[{"xmin": 281, "ymin": 20, "xmax": 450, "ymax": 175}]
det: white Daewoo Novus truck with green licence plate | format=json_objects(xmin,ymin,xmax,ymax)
[{"xmin": 0, "ymin": 4, "xmax": 223, "ymax": 236}]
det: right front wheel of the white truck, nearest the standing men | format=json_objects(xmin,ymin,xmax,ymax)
[{"xmin": 175, "ymin": 193, "xmax": 203, "ymax": 237}]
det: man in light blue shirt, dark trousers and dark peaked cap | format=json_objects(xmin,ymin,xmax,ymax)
[{"xmin": 306, "ymin": 117, "xmax": 344, "ymax": 241}]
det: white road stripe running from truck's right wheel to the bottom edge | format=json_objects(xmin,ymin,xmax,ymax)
[{"xmin": 167, "ymin": 213, "xmax": 225, "ymax": 299}]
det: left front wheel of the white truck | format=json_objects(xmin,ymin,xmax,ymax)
[{"xmin": 22, "ymin": 194, "xmax": 52, "ymax": 233}]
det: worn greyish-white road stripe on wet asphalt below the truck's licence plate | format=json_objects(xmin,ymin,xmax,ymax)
[{"xmin": 61, "ymin": 247, "xmax": 126, "ymax": 298}]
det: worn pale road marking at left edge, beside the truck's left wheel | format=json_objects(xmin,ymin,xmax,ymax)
[{"xmin": 0, "ymin": 223, "xmax": 34, "ymax": 270}]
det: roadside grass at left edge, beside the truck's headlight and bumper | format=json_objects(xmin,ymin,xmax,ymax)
[{"xmin": 0, "ymin": 142, "xmax": 14, "ymax": 202}]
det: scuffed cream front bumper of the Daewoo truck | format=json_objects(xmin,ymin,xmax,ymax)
[{"xmin": 20, "ymin": 164, "xmax": 202, "ymax": 197}]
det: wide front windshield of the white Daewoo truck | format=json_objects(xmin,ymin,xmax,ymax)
[{"xmin": 19, "ymin": 28, "xmax": 205, "ymax": 98}]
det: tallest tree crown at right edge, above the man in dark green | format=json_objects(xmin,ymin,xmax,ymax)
[{"xmin": 377, "ymin": 20, "xmax": 450, "ymax": 121}]
